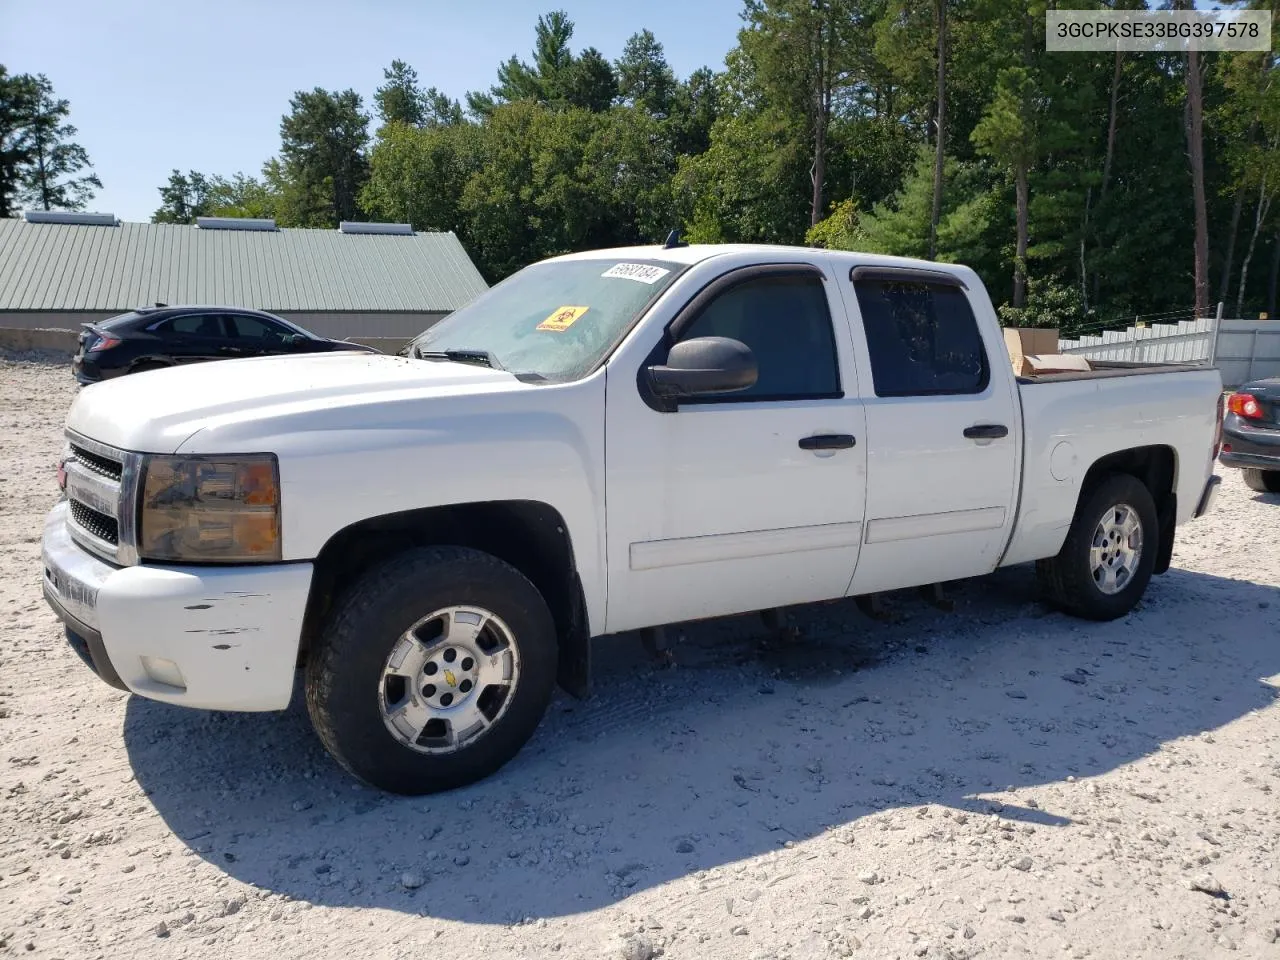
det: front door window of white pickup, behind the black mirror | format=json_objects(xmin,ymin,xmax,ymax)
[{"xmin": 680, "ymin": 276, "xmax": 840, "ymax": 401}]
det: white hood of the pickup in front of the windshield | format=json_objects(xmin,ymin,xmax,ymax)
[{"xmin": 67, "ymin": 352, "xmax": 524, "ymax": 453}]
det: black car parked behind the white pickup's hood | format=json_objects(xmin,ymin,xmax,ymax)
[{"xmin": 72, "ymin": 306, "xmax": 379, "ymax": 384}]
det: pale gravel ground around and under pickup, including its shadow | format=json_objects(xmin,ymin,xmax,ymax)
[{"xmin": 0, "ymin": 358, "xmax": 1280, "ymax": 960}]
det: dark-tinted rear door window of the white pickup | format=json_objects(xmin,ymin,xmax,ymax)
[{"xmin": 854, "ymin": 279, "xmax": 991, "ymax": 397}]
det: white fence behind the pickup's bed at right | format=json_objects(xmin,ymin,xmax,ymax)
[{"xmin": 1059, "ymin": 319, "xmax": 1280, "ymax": 387}]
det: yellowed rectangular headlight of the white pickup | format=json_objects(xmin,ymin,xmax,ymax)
[{"xmin": 138, "ymin": 453, "xmax": 280, "ymax": 563}]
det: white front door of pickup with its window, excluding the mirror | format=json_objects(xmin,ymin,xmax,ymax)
[{"xmin": 605, "ymin": 259, "xmax": 867, "ymax": 632}]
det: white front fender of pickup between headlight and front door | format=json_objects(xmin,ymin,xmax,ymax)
[{"xmin": 179, "ymin": 375, "xmax": 605, "ymax": 634}]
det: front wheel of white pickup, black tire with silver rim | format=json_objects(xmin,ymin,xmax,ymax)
[{"xmin": 305, "ymin": 547, "xmax": 558, "ymax": 795}]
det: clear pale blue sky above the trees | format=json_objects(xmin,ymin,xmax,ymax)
[{"xmin": 0, "ymin": 0, "xmax": 742, "ymax": 220}]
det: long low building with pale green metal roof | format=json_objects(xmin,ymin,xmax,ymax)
[{"xmin": 0, "ymin": 211, "xmax": 486, "ymax": 342}]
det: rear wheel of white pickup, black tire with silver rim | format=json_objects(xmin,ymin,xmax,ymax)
[{"xmin": 1037, "ymin": 474, "xmax": 1160, "ymax": 621}]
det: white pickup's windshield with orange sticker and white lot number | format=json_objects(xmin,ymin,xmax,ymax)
[{"xmin": 407, "ymin": 260, "xmax": 684, "ymax": 381}]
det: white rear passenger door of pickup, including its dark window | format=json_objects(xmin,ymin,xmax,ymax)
[{"xmin": 842, "ymin": 266, "xmax": 1020, "ymax": 595}]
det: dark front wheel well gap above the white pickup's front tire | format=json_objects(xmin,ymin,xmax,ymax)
[{"xmin": 300, "ymin": 500, "xmax": 590, "ymax": 696}]
